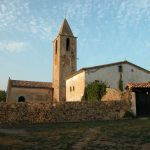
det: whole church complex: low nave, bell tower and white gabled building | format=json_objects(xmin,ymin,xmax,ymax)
[{"xmin": 6, "ymin": 19, "xmax": 150, "ymax": 102}]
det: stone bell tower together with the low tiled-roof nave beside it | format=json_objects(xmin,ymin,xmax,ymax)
[{"xmin": 6, "ymin": 19, "xmax": 77, "ymax": 102}]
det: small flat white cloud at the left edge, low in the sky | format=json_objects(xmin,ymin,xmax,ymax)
[{"xmin": 0, "ymin": 41, "xmax": 28, "ymax": 53}]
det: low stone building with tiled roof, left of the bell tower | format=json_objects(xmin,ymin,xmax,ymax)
[{"xmin": 6, "ymin": 79, "xmax": 53, "ymax": 103}]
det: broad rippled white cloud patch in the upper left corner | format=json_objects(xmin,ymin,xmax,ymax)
[{"xmin": 0, "ymin": 0, "xmax": 51, "ymax": 38}]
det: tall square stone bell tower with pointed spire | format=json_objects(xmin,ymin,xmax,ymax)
[{"xmin": 53, "ymin": 18, "xmax": 77, "ymax": 102}]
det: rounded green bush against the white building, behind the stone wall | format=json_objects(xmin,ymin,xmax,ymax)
[{"xmin": 82, "ymin": 81, "xmax": 107, "ymax": 101}]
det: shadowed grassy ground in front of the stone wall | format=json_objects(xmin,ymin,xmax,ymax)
[{"xmin": 0, "ymin": 118, "xmax": 150, "ymax": 150}]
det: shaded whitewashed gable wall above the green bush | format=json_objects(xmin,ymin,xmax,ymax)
[{"xmin": 85, "ymin": 64, "xmax": 150, "ymax": 89}]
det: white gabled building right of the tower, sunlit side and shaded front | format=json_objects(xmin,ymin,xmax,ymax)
[{"xmin": 66, "ymin": 61, "xmax": 150, "ymax": 101}]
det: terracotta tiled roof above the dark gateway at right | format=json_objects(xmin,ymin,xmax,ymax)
[{"xmin": 127, "ymin": 82, "xmax": 150, "ymax": 89}]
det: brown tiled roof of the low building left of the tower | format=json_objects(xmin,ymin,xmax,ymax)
[{"xmin": 10, "ymin": 80, "xmax": 52, "ymax": 88}]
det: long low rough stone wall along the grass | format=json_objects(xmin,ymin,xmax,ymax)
[{"xmin": 0, "ymin": 101, "xmax": 129, "ymax": 123}]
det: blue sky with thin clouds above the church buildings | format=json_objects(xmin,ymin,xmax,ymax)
[{"xmin": 0, "ymin": 0, "xmax": 150, "ymax": 90}]
